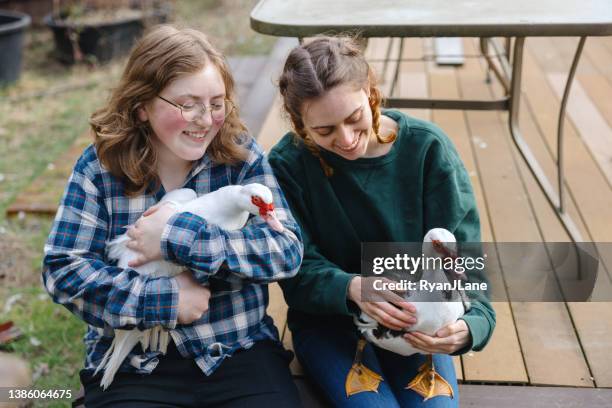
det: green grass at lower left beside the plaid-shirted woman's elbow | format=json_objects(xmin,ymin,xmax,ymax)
[{"xmin": 0, "ymin": 216, "xmax": 86, "ymax": 407}]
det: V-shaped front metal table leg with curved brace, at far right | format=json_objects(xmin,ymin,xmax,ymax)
[{"xmin": 509, "ymin": 37, "xmax": 586, "ymax": 242}]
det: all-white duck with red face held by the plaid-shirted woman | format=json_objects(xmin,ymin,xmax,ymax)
[{"xmin": 94, "ymin": 183, "xmax": 284, "ymax": 389}]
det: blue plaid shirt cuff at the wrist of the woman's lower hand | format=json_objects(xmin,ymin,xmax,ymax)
[{"xmin": 144, "ymin": 277, "xmax": 179, "ymax": 329}]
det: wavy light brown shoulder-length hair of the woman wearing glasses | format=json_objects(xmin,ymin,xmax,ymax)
[{"xmin": 89, "ymin": 25, "xmax": 247, "ymax": 196}]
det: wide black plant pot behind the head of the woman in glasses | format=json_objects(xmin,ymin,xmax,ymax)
[{"xmin": 44, "ymin": 6, "xmax": 168, "ymax": 64}]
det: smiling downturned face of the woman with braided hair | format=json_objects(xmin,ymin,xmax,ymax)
[{"xmin": 302, "ymin": 85, "xmax": 376, "ymax": 160}]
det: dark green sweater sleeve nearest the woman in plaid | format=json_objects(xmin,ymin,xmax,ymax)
[{"xmin": 269, "ymin": 150, "xmax": 357, "ymax": 315}]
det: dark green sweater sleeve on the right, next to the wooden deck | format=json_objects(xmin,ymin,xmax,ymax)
[{"xmin": 423, "ymin": 135, "xmax": 496, "ymax": 354}]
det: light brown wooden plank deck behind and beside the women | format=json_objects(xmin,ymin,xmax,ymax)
[{"xmin": 258, "ymin": 37, "xmax": 612, "ymax": 396}]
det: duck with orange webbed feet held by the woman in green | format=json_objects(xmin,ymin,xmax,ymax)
[{"xmin": 346, "ymin": 228, "xmax": 470, "ymax": 401}]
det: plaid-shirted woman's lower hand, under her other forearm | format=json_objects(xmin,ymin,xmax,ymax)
[{"xmin": 174, "ymin": 271, "xmax": 210, "ymax": 324}]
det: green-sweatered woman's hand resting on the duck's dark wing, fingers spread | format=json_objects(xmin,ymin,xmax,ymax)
[{"xmin": 347, "ymin": 276, "xmax": 416, "ymax": 330}]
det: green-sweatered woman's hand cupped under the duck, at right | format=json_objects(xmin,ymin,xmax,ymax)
[{"xmin": 404, "ymin": 319, "xmax": 472, "ymax": 354}]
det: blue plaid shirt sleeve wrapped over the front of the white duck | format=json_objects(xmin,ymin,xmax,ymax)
[{"xmin": 161, "ymin": 144, "xmax": 302, "ymax": 284}]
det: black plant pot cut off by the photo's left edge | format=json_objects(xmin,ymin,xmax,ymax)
[{"xmin": 0, "ymin": 10, "xmax": 31, "ymax": 85}]
